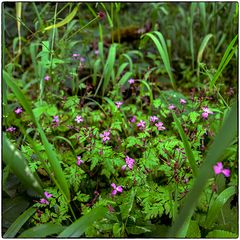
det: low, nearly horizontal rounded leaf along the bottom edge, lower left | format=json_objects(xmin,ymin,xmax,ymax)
[{"xmin": 18, "ymin": 223, "xmax": 64, "ymax": 238}]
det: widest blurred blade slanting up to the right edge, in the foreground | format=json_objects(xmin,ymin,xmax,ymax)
[{"xmin": 169, "ymin": 101, "xmax": 238, "ymax": 237}]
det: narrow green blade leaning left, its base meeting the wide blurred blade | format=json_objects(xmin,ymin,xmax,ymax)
[{"xmin": 172, "ymin": 112, "xmax": 198, "ymax": 177}]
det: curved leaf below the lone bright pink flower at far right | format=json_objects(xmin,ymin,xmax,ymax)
[{"xmin": 205, "ymin": 186, "xmax": 236, "ymax": 228}]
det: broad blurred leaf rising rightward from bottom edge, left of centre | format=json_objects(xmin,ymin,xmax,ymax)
[{"xmin": 58, "ymin": 207, "xmax": 108, "ymax": 238}]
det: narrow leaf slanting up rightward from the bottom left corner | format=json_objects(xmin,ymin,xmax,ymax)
[{"xmin": 3, "ymin": 207, "xmax": 36, "ymax": 238}]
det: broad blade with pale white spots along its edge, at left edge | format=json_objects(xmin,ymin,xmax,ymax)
[{"xmin": 3, "ymin": 134, "xmax": 43, "ymax": 195}]
